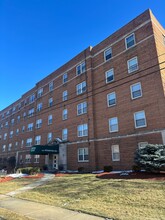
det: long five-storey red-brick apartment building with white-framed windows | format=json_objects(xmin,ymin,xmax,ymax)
[{"xmin": 0, "ymin": 10, "xmax": 165, "ymax": 171}]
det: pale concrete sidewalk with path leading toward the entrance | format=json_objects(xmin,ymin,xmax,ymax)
[{"xmin": 0, "ymin": 174, "xmax": 104, "ymax": 220}]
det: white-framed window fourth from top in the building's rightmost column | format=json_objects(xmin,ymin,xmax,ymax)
[{"xmin": 134, "ymin": 111, "xmax": 147, "ymax": 128}]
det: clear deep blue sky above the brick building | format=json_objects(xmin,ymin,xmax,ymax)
[{"xmin": 0, "ymin": 0, "xmax": 165, "ymax": 110}]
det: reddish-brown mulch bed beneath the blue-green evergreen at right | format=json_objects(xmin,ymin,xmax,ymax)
[{"xmin": 96, "ymin": 172, "xmax": 165, "ymax": 180}]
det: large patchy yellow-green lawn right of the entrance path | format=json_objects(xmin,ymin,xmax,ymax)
[{"xmin": 13, "ymin": 174, "xmax": 165, "ymax": 220}]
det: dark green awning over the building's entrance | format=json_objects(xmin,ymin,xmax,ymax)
[{"xmin": 30, "ymin": 144, "xmax": 59, "ymax": 155}]
